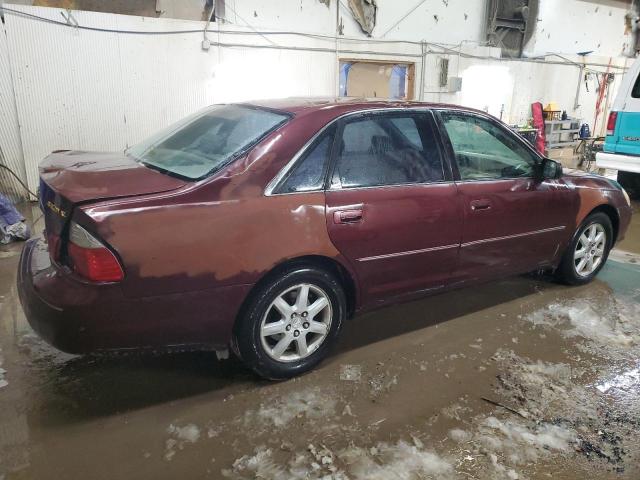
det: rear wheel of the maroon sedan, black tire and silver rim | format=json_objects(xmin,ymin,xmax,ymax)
[{"xmin": 232, "ymin": 266, "xmax": 347, "ymax": 380}]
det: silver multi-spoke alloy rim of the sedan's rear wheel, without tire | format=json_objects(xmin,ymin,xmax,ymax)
[{"xmin": 260, "ymin": 283, "xmax": 332, "ymax": 362}]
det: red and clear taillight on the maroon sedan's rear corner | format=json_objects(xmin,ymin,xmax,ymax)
[{"xmin": 67, "ymin": 222, "xmax": 124, "ymax": 282}]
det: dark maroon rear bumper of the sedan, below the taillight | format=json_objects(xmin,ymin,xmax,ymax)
[{"xmin": 18, "ymin": 239, "xmax": 251, "ymax": 353}]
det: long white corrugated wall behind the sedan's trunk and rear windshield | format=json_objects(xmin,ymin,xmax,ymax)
[{"xmin": 5, "ymin": 5, "xmax": 337, "ymax": 193}]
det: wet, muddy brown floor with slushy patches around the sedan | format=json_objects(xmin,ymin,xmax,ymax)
[{"xmin": 0, "ymin": 201, "xmax": 640, "ymax": 480}]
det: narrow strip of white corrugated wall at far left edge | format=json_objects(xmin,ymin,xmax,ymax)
[{"xmin": 0, "ymin": 23, "xmax": 26, "ymax": 201}]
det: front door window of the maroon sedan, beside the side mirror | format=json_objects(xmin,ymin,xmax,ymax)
[{"xmin": 441, "ymin": 112, "xmax": 536, "ymax": 180}]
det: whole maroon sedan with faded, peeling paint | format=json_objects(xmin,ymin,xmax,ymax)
[{"xmin": 18, "ymin": 99, "xmax": 631, "ymax": 378}]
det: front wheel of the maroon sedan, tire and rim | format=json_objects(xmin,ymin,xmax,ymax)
[{"xmin": 556, "ymin": 212, "xmax": 613, "ymax": 285}]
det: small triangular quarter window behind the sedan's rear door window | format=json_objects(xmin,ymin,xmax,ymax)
[{"xmin": 277, "ymin": 125, "xmax": 336, "ymax": 193}]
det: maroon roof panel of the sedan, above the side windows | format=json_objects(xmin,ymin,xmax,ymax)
[{"xmin": 243, "ymin": 97, "xmax": 486, "ymax": 115}]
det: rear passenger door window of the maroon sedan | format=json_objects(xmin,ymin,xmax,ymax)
[{"xmin": 332, "ymin": 114, "xmax": 444, "ymax": 188}]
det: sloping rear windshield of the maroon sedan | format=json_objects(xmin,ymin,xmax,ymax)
[{"xmin": 126, "ymin": 105, "xmax": 289, "ymax": 180}]
